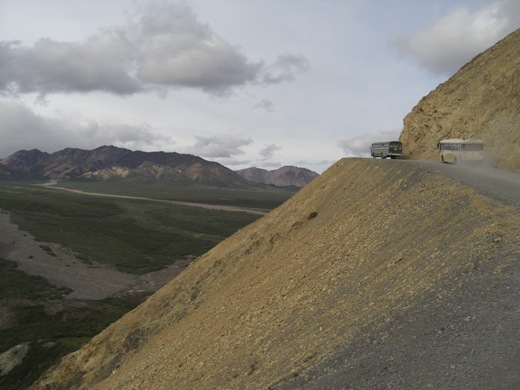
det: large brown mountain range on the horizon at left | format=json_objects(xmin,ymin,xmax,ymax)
[{"xmin": 0, "ymin": 146, "xmax": 255, "ymax": 187}]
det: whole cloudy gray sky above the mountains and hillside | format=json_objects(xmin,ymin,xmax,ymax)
[{"xmin": 0, "ymin": 0, "xmax": 520, "ymax": 173}]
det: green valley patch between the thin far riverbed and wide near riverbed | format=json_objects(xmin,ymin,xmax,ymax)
[{"xmin": 0, "ymin": 186, "xmax": 266, "ymax": 274}]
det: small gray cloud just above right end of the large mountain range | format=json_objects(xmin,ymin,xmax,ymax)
[{"xmin": 181, "ymin": 136, "xmax": 253, "ymax": 159}]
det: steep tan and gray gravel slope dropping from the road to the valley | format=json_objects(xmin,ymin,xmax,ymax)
[{"xmin": 33, "ymin": 159, "xmax": 520, "ymax": 389}]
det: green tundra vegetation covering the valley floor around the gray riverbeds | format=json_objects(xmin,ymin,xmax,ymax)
[{"xmin": 0, "ymin": 181, "xmax": 295, "ymax": 389}]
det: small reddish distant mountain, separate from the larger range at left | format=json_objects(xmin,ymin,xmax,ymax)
[{"xmin": 236, "ymin": 166, "xmax": 319, "ymax": 188}]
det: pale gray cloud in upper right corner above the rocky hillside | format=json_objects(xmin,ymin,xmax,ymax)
[{"xmin": 394, "ymin": 0, "xmax": 520, "ymax": 76}]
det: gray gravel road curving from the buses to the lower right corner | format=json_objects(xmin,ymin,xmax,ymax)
[{"xmin": 272, "ymin": 160, "xmax": 520, "ymax": 390}]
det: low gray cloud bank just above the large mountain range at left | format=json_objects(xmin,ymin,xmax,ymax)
[{"xmin": 0, "ymin": 101, "xmax": 167, "ymax": 158}]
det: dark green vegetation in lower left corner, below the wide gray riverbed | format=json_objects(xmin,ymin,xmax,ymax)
[{"xmin": 0, "ymin": 295, "xmax": 146, "ymax": 389}]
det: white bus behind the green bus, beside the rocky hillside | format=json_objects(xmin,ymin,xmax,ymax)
[{"xmin": 437, "ymin": 138, "xmax": 484, "ymax": 164}]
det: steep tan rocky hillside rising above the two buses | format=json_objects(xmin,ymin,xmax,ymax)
[{"xmin": 400, "ymin": 29, "xmax": 520, "ymax": 170}]
